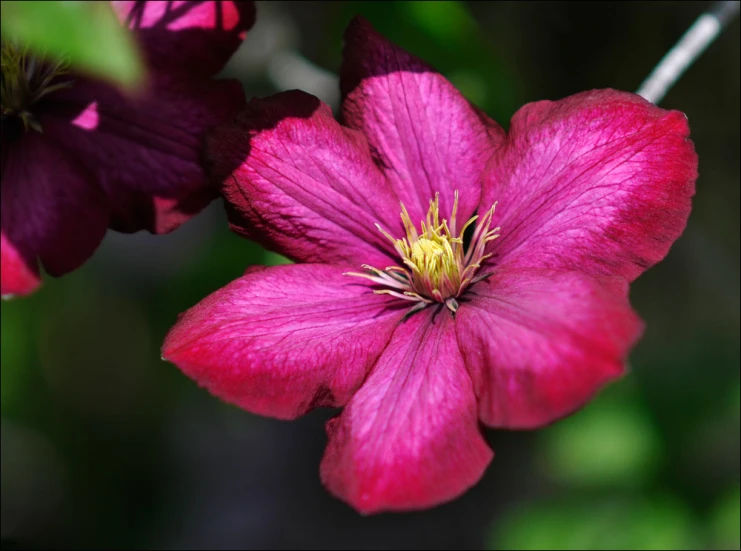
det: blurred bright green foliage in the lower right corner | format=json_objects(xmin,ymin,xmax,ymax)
[{"xmin": 490, "ymin": 381, "xmax": 739, "ymax": 550}]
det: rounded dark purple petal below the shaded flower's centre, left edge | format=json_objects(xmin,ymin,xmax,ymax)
[{"xmin": 0, "ymin": 128, "xmax": 109, "ymax": 280}]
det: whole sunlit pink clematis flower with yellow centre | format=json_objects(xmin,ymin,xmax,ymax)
[{"xmin": 163, "ymin": 20, "xmax": 697, "ymax": 513}]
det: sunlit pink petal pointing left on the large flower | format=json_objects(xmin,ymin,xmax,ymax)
[{"xmin": 162, "ymin": 264, "xmax": 404, "ymax": 419}]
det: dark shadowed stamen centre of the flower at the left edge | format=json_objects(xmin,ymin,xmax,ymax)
[{"xmin": 0, "ymin": 42, "xmax": 70, "ymax": 132}]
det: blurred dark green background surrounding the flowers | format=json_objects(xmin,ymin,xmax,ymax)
[{"xmin": 1, "ymin": 2, "xmax": 741, "ymax": 549}]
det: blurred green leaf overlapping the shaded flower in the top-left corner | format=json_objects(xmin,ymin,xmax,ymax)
[{"xmin": 0, "ymin": 1, "xmax": 144, "ymax": 89}]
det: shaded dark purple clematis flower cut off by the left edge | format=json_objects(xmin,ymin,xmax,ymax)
[{"xmin": 0, "ymin": 2, "xmax": 255, "ymax": 297}]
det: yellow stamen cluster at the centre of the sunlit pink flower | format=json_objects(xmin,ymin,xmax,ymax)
[{"xmin": 345, "ymin": 191, "xmax": 500, "ymax": 313}]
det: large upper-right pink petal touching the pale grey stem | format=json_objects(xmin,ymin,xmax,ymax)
[{"xmin": 482, "ymin": 90, "xmax": 697, "ymax": 281}]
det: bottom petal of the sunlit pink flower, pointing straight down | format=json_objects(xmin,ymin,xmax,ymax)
[{"xmin": 321, "ymin": 310, "xmax": 493, "ymax": 513}]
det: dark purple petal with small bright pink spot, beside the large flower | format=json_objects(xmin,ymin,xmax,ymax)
[{"xmin": 48, "ymin": 74, "xmax": 244, "ymax": 233}]
